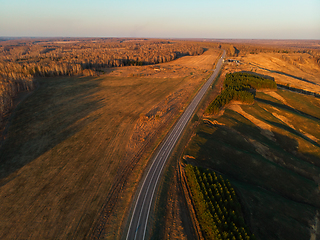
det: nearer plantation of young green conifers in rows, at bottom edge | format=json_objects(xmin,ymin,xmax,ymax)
[{"xmin": 185, "ymin": 165, "xmax": 255, "ymax": 240}]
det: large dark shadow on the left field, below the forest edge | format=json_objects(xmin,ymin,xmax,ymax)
[{"xmin": 0, "ymin": 77, "xmax": 102, "ymax": 183}]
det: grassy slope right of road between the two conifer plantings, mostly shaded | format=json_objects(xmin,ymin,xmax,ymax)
[{"xmin": 184, "ymin": 90, "xmax": 320, "ymax": 239}]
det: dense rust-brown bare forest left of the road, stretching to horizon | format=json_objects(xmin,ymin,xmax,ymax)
[{"xmin": 0, "ymin": 38, "xmax": 204, "ymax": 120}]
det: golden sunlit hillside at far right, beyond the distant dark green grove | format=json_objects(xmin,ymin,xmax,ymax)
[{"xmin": 221, "ymin": 41, "xmax": 320, "ymax": 94}]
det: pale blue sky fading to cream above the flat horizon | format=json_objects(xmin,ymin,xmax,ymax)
[{"xmin": 0, "ymin": 0, "xmax": 320, "ymax": 39}]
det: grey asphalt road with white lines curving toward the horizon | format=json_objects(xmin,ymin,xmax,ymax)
[{"xmin": 126, "ymin": 51, "xmax": 226, "ymax": 240}]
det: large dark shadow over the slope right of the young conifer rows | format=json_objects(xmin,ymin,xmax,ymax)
[{"xmin": 186, "ymin": 116, "xmax": 320, "ymax": 240}]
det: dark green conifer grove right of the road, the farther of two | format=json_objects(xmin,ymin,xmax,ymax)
[{"xmin": 207, "ymin": 72, "xmax": 277, "ymax": 114}]
